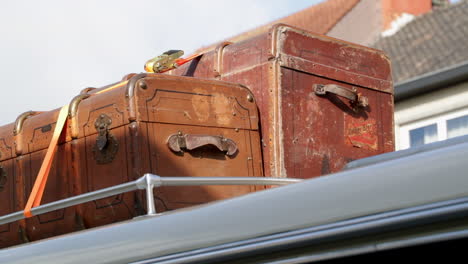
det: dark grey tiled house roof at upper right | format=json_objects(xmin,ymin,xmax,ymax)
[{"xmin": 374, "ymin": 1, "xmax": 468, "ymax": 83}]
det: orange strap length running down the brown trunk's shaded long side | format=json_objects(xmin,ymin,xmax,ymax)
[{"xmin": 24, "ymin": 105, "xmax": 68, "ymax": 217}]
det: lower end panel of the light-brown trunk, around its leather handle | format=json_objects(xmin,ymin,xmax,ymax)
[{"xmin": 149, "ymin": 123, "xmax": 262, "ymax": 210}]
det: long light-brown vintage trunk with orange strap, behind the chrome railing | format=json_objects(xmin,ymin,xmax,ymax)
[{"xmin": 0, "ymin": 74, "xmax": 264, "ymax": 247}]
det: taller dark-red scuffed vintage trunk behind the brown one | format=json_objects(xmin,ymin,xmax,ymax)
[{"xmin": 168, "ymin": 24, "xmax": 394, "ymax": 178}]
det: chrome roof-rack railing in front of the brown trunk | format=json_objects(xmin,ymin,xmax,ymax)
[{"xmin": 0, "ymin": 173, "xmax": 301, "ymax": 225}]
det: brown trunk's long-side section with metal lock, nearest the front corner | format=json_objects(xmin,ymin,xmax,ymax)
[{"xmin": 71, "ymin": 86, "xmax": 142, "ymax": 228}]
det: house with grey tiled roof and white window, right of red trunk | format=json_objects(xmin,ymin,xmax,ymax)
[{"xmin": 374, "ymin": 1, "xmax": 468, "ymax": 149}]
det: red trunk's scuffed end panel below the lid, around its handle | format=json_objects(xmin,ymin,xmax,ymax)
[{"xmin": 281, "ymin": 69, "xmax": 393, "ymax": 178}]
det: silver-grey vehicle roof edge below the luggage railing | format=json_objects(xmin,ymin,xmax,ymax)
[{"xmin": 0, "ymin": 140, "xmax": 468, "ymax": 263}]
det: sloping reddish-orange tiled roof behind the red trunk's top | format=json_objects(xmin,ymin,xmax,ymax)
[{"xmin": 197, "ymin": 0, "xmax": 360, "ymax": 53}]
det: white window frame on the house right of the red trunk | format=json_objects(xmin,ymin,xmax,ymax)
[{"xmin": 400, "ymin": 108, "xmax": 468, "ymax": 149}]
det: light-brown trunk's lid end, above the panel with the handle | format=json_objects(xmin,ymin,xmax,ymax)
[{"xmin": 136, "ymin": 78, "xmax": 258, "ymax": 130}]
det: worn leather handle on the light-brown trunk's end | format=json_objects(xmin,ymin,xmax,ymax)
[{"xmin": 167, "ymin": 132, "xmax": 237, "ymax": 156}]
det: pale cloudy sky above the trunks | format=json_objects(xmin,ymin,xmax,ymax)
[{"xmin": 0, "ymin": 0, "xmax": 323, "ymax": 125}]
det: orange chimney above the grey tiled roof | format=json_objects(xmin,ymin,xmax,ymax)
[{"xmin": 382, "ymin": 0, "xmax": 434, "ymax": 31}]
